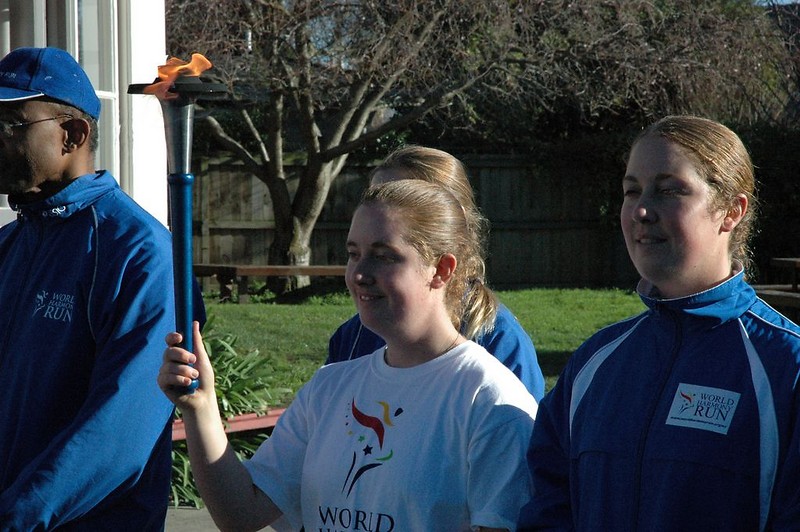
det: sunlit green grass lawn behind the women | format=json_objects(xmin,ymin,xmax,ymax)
[{"xmin": 206, "ymin": 285, "xmax": 644, "ymax": 406}]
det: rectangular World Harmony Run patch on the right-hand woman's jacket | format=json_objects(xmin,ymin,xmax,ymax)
[{"xmin": 667, "ymin": 383, "xmax": 741, "ymax": 434}]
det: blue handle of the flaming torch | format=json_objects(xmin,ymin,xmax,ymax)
[{"xmin": 167, "ymin": 173, "xmax": 200, "ymax": 393}]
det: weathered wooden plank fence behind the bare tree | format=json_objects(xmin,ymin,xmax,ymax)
[{"xmin": 189, "ymin": 156, "xmax": 637, "ymax": 288}]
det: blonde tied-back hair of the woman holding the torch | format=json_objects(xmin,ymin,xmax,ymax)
[{"xmin": 361, "ymin": 179, "xmax": 497, "ymax": 339}]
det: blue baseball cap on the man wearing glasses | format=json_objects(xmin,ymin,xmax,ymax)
[{"xmin": 0, "ymin": 48, "xmax": 100, "ymax": 119}]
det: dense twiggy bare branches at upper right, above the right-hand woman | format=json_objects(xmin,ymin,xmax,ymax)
[{"xmin": 424, "ymin": 0, "xmax": 796, "ymax": 147}]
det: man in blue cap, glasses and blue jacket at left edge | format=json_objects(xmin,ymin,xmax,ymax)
[{"xmin": 0, "ymin": 48, "xmax": 184, "ymax": 531}]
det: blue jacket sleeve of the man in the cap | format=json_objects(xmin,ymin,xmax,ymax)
[{"xmin": 0, "ymin": 227, "xmax": 175, "ymax": 530}]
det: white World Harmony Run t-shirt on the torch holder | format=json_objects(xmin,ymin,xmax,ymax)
[{"xmin": 245, "ymin": 342, "xmax": 537, "ymax": 532}]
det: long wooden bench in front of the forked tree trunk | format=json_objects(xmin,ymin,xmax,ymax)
[{"xmin": 193, "ymin": 264, "xmax": 347, "ymax": 303}]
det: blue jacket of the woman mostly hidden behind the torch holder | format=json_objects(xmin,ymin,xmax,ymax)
[{"xmin": 325, "ymin": 305, "xmax": 544, "ymax": 402}]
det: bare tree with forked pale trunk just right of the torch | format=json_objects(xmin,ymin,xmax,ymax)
[{"xmin": 166, "ymin": 0, "xmax": 514, "ymax": 288}]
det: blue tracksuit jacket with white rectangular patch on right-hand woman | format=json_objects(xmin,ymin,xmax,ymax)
[{"xmin": 523, "ymin": 272, "xmax": 800, "ymax": 531}]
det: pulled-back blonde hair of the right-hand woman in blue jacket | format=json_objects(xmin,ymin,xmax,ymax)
[{"xmin": 633, "ymin": 116, "xmax": 758, "ymax": 271}]
